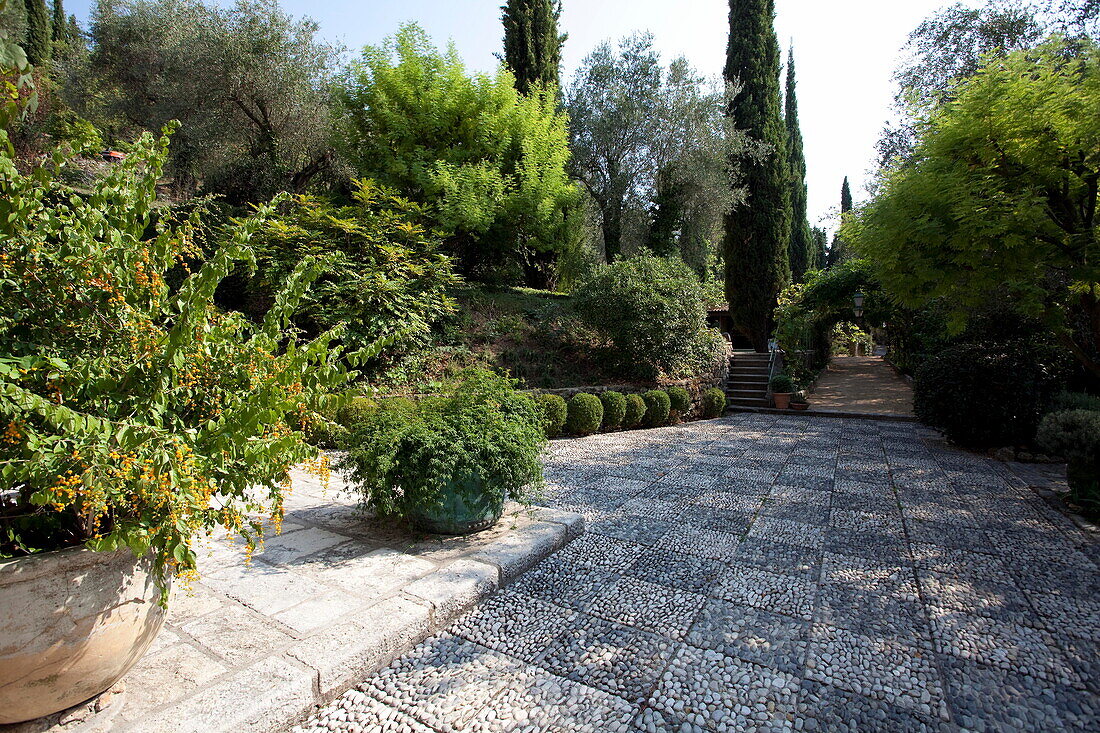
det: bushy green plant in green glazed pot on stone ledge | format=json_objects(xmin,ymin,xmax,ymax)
[{"xmin": 340, "ymin": 370, "xmax": 546, "ymax": 535}]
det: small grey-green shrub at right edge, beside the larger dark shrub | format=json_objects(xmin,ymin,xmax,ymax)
[{"xmin": 1036, "ymin": 409, "xmax": 1100, "ymax": 508}]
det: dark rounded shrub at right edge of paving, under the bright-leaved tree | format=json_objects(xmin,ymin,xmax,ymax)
[{"xmin": 913, "ymin": 341, "xmax": 1059, "ymax": 448}]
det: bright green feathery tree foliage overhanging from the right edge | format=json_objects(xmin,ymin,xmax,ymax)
[{"xmin": 842, "ymin": 40, "xmax": 1100, "ymax": 374}]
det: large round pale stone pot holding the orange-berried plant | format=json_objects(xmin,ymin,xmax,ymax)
[{"xmin": 0, "ymin": 547, "xmax": 165, "ymax": 723}]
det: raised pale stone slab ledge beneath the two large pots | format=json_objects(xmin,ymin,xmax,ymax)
[{"xmin": 0, "ymin": 457, "xmax": 584, "ymax": 733}]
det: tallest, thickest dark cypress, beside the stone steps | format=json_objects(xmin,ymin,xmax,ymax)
[{"xmin": 724, "ymin": 0, "xmax": 791, "ymax": 351}]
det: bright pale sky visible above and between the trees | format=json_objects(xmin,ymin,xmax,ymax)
[{"xmin": 66, "ymin": 0, "xmax": 981, "ymax": 228}]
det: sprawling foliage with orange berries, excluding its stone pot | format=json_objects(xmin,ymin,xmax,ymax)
[{"xmin": 0, "ymin": 122, "xmax": 352, "ymax": 592}]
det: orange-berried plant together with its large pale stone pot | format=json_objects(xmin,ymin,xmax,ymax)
[{"xmin": 0, "ymin": 125, "xmax": 349, "ymax": 723}]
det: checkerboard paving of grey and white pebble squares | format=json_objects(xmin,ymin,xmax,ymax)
[{"xmin": 297, "ymin": 415, "xmax": 1100, "ymax": 733}]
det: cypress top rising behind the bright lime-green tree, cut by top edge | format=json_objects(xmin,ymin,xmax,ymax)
[{"xmin": 501, "ymin": 0, "xmax": 567, "ymax": 95}]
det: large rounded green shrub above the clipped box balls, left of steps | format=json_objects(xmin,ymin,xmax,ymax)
[{"xmin": 573, "ymin": 256, "xmax": 707, "ymax": 378}]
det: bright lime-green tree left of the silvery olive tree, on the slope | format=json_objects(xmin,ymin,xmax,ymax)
[{"xmin": 338, "ymin": 24, "xmax": 583, "ymax": 287}]
